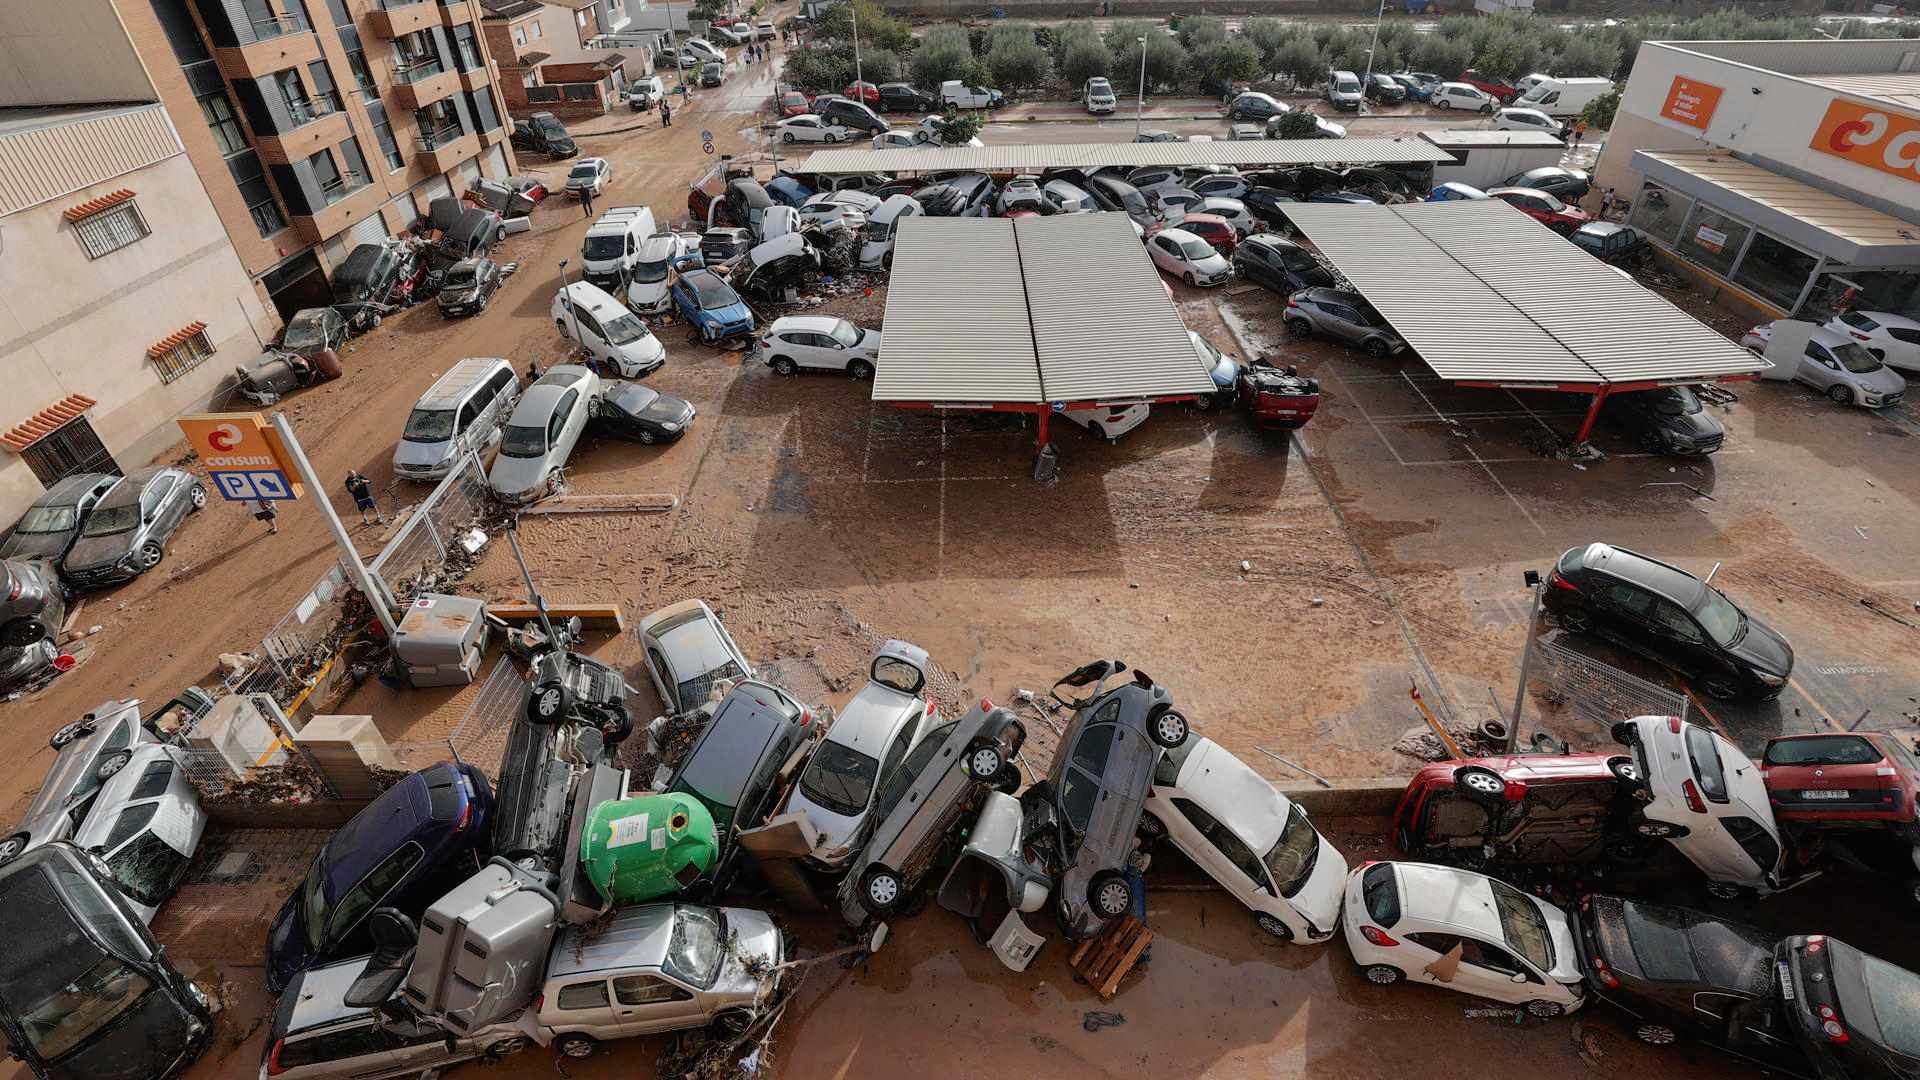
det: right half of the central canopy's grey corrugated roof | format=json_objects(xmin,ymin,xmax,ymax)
[{"xmin": 1021, "ymin": 213, "xmax": 1215, "ymax": 402}]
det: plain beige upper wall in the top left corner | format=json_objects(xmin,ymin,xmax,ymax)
[{"xmin": 0, "ymin": 0, "xmax": 154, "ymax": 106}]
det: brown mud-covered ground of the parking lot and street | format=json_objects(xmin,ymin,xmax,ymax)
[{"xmin": 0, "ymin": 23, "xmax": 1920, "ymax": 1078}]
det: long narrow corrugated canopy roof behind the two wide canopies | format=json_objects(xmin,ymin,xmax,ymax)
[{"xmin": 793, "ymin": 138, "xmax": 1452, "ymax": 175}]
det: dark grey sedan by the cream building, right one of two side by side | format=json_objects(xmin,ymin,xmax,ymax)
[{"xmin": 60, "ymin": 467, "xmax": 207, "ymax": 588}]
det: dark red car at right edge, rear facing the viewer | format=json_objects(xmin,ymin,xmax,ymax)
[{"xmin": 1761, "ymin": 732, "xmax": 1920, "ymax": 828}]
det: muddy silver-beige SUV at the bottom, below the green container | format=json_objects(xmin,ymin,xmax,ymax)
[{"xmin": 532, "ymin": 903, "xmax": 787, "ymax": 1057}]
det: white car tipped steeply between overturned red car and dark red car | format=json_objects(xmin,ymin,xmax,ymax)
[{"xmin": 1613, "ymin": 717, "xmax": 1795, "ymax": 897}]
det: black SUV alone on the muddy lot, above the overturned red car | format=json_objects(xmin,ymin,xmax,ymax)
[{"xmin": 1542, "ymin": 544, "xmax": 1793, "ymax": 698}]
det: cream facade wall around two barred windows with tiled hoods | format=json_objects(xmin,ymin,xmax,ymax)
[{"xmin": 0, "ymin": 154, "xmax": 275, "ymax": 523}]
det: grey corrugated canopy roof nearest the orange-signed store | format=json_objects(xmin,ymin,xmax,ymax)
[{"xmin": 1288, "ymin": 200, "xmax": 1770, "ymax": 384}]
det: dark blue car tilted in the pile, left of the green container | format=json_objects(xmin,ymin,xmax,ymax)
[{"xmin": 267, "ymin": 761, "xmax": 493, "ymax": 994}]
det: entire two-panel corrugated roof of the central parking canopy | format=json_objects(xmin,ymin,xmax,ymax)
[{"xmin": 874, "ymin": 213, "xmax": 1213, "ymax": 405}]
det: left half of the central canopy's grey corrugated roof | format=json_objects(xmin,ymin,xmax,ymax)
[{"xmin": 874, "ymin": 217, "xmax": 1044, "ymax": 404}]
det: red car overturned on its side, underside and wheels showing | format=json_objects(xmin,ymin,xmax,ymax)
[{"xmin": 1394, "ymin": 753, "xmax": 1642, "ymax": 867}]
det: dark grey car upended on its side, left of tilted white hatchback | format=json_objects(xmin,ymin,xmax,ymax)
[{"xmin": 1020, "ymin": 659, "xmax": 1190, "ymax": 940}]
